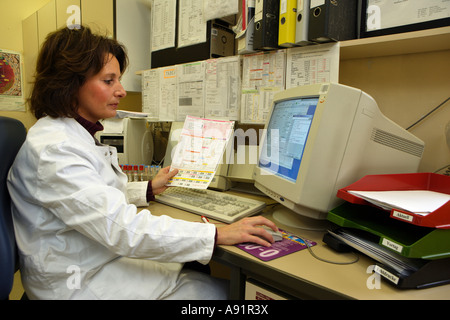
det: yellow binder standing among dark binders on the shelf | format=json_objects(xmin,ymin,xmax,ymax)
[{"xmin": 278, "ymin": 0, "xmax": 297, "ymax": 47}]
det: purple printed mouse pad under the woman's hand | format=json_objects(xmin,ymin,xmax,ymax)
[{"xmin": 236, "ymin": 229, "xmax": 317, "ymax": 261}]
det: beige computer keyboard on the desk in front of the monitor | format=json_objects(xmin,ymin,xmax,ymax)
[{"xmin": 155, "ymin": 187, "xmax": 266, "ymax": 223}]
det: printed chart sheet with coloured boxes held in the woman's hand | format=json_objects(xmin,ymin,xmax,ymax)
[{"xmin": 167, "ymin": 116, "xmax": 234, "ymax": 189}]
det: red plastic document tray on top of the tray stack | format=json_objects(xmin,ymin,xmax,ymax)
[{"xmin": 337, "ymin": 173, "xmax": 450, "ymax": 229}]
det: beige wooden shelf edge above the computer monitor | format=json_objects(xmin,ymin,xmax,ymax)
[{"xmin": 341, "ymin": 27, "xmax": 450, "ymax": 60}]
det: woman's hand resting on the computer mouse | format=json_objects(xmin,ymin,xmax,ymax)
[{"xmin": 217, "ymin": 216, "xmax": 278, "ymax": 247}]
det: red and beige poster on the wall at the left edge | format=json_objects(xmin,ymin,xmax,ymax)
[{"xmin": 0, "ymin": 49, "xmax": 25, "ymax": 111}]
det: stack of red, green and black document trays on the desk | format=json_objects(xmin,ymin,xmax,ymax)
[{"xmin": 328, "ymin": 173, "xmax": 450, "ymax": 288}]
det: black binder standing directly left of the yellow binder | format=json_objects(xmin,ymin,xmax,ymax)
[{"xmin": 253, "ymin": 0, "xmax": 280, "ymax": 50}]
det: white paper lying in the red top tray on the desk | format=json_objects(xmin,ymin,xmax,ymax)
[{"xmin": 349, "ymin": 190, "xmax": 450, "ymax": 216}]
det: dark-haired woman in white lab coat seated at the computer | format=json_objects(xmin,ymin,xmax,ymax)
[{"xmin": 8, "ymin": 27, "xmax": 276, "ymax": 299}]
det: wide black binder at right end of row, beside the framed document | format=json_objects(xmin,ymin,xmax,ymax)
[{"xmin": 308, "ymin": 0, "xmax": 358, "ymax": 43}]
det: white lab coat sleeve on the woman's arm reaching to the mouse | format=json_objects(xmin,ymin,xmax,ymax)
[{"xmin": 36, "ymin": 143, "xmax": 216, "ymax": 263}]
